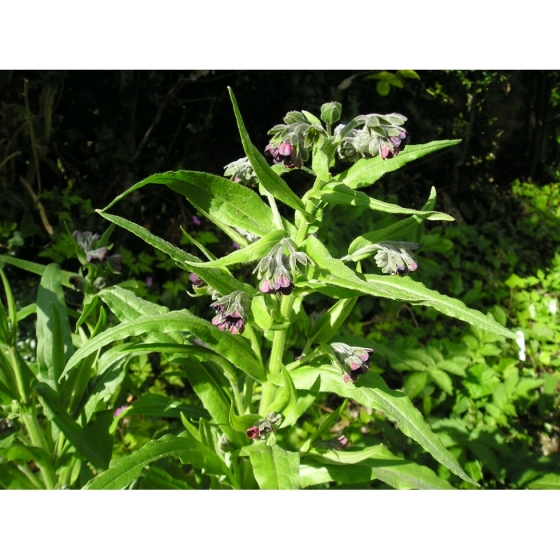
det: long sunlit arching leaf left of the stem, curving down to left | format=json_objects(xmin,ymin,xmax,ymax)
[{"xmin": 63, "ymin": 310, "xmax": 266, "ymax": 381}]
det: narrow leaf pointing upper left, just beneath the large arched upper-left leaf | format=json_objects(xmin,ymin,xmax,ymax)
[{"xmin": 97, "ymin": 210, "xmax": 257, "ymax": 295}]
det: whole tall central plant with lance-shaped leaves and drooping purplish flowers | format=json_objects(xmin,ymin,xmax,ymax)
[{"xmin": 1, "ymin": 90, "xmax": 516, "ymax": 489}]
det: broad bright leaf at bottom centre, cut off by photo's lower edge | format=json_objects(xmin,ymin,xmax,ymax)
[{"xmin": 243, "ymin": 441, "xmax": 299, "ymax": 490}]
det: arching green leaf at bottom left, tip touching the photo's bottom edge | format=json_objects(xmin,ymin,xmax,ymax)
[{"xmin": 84, "ymin": 432, "xmax": 229, "ymax": 490}]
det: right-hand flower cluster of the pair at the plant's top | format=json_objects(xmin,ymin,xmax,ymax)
[{"xmin": 334, "ymin": 113, "xmax": 410, "ymax": 161}]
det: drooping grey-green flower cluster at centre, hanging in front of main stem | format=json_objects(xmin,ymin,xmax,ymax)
[{"xmin": 253, "ymin": 238, "xmax": 314, "ymax": 296}]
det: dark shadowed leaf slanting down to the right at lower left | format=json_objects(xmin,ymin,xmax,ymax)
[{"xmin": 33, "ymin": 383, "xmax": 109, "ymax": 469}]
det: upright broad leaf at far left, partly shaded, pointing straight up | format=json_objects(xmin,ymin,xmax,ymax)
[{"xmin": 36, "ymin": 263, "xmax": 74, "ymax": 391}]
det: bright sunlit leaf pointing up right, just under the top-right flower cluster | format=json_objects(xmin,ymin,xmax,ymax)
[{"xmin": 335, "ymin": 140, "xmax": 461, "ymax": 189}]
